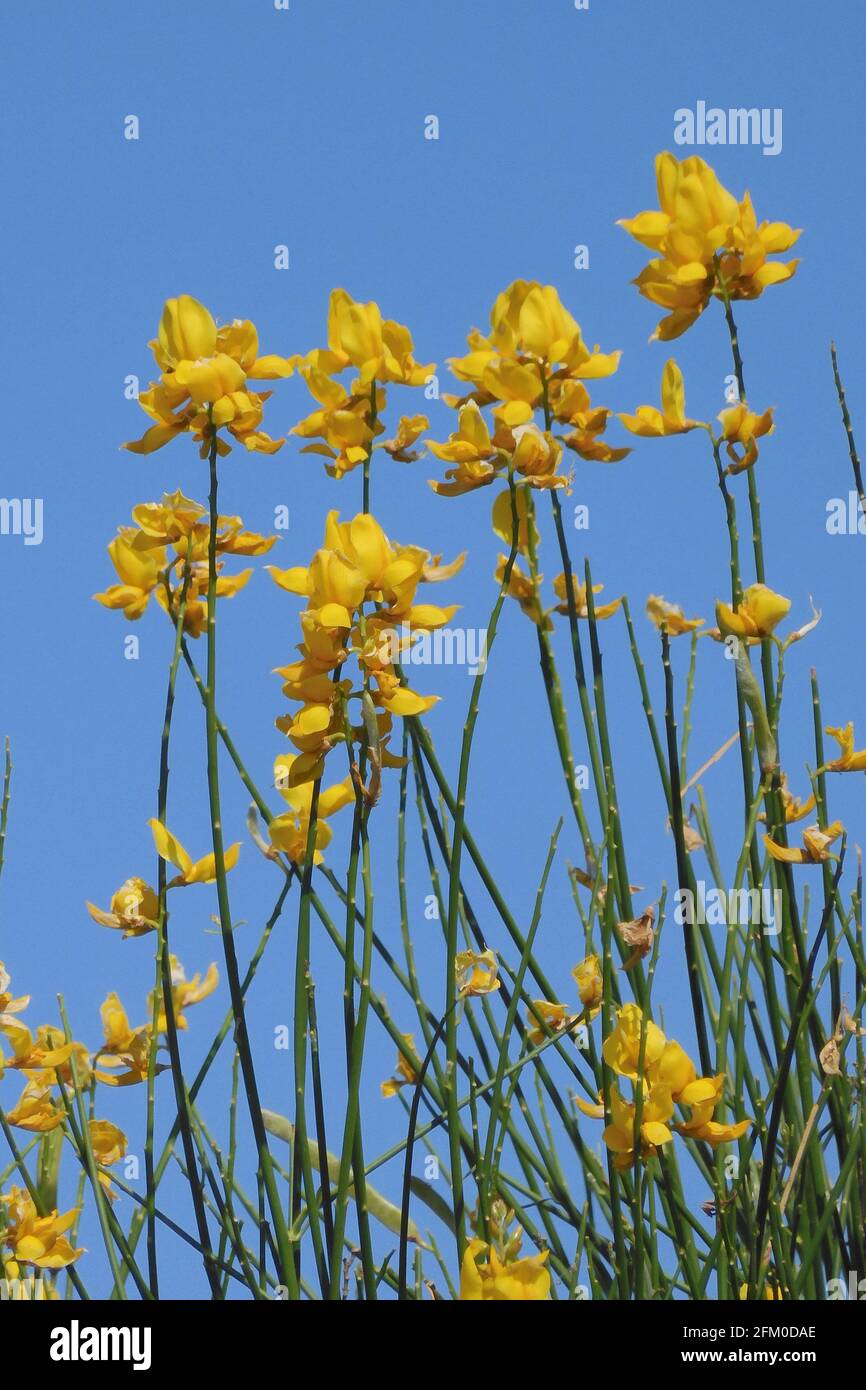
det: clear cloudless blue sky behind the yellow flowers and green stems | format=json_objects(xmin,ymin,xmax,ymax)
[{"xmin": 0, "ymin": 0, "xmax": 866, "ymax": 1290}]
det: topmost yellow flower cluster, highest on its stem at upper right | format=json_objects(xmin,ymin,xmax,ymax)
[{"xmin": 619, "ymin": 152, "xmax": 799, "ymax": 341}]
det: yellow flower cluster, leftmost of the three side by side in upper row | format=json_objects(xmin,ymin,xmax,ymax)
[{"xmin": 124, "ymin": 295, "xmax": 295, "ymax": 457}]
